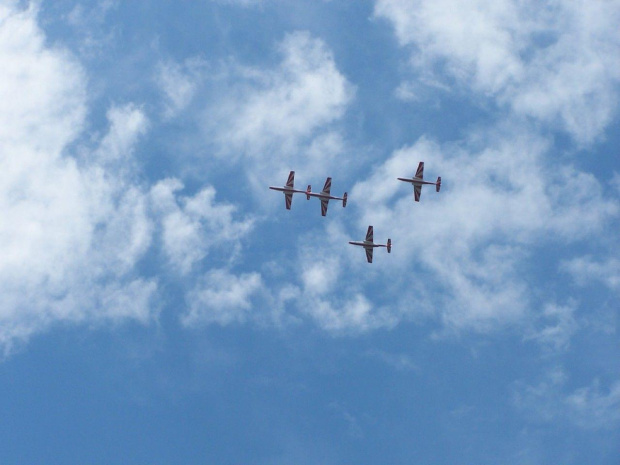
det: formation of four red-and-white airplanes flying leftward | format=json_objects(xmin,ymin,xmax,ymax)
[{"xmin": 269, "ymin": 161, "xmax": 441, "ymax": 263}]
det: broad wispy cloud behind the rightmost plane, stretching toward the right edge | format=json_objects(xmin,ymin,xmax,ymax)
[{"xmin": 351, "ymin": 128, "xmax": 618, "ymax": 330}]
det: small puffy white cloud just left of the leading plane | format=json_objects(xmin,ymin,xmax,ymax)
[{"xmin": 151, "ymin": 179, "xmax": 253, "ymax": 273}]
